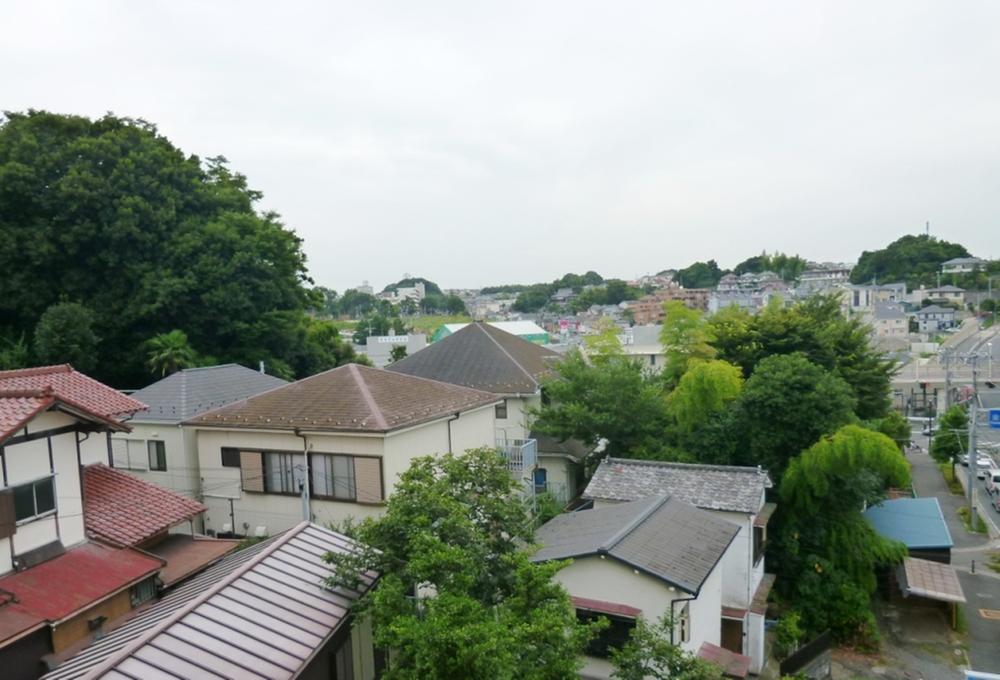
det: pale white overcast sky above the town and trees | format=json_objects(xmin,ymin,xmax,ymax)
[{"xmin": 0, "ymin": 0, "xmax": 1000, "ymax": 290}]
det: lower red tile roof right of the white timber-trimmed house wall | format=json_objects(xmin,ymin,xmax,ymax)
[{"xmin": 83, "ymin": 463, "xmax": 208, "ymax": 545}]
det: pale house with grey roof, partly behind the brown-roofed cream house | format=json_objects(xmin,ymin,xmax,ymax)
[{"xmin": 96, "ymin": 364, "xmax": 288, "ymax": 498}]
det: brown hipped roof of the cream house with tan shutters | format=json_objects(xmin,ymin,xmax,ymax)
[{"xmin": 185, "ymin": 364, "xmax": 497, "ymax": 432}]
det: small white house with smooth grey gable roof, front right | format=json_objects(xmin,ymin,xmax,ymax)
[{"xmin": 531, "ymin": 496, "xmax": 750, "ymax": 678}]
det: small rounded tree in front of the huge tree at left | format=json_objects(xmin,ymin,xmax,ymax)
[{"xmin": 35, "ymin": 302, "xmax": 98, "ymax": 373}]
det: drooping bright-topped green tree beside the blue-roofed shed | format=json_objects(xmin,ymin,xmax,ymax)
[{"xmin": 776, "ymin": 425, "xmax": 910, "ymax": 643}]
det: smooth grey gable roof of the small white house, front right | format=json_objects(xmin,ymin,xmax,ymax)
[{"xmin": 531, "ymin": 496, "xmax": 739, "ymax": 594}]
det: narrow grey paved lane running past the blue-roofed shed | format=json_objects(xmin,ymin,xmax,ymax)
[{"xmin": 909, "ymin": 444, "xmax": 1000, "ymax": 673}]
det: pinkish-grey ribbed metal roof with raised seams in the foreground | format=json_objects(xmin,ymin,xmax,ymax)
[{"xmin": 44, "ymin": 522, "xmax": 376, "ymax": 680}]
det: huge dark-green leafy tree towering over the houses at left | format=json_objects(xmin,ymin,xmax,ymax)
[{"xmin": 0, "ymin": 111, "xmax": 340, "ymax": 386}]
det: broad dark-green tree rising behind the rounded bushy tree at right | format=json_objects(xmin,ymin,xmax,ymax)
[{"xmin": 708, "ymin": 295, "xmax": 897, "ymax": 420}]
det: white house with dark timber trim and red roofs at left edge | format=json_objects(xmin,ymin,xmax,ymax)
[{"xmin": 0, "ymin": 365, "xmax": 163, "ymax": 680}]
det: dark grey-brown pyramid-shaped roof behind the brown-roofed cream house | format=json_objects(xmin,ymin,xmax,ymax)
[{"xmin": 388, "ymin": 322, "xmax": 560, "ymax": 394}]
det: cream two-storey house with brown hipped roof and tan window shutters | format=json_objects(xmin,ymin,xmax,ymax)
[{"xmin": 185, "ymin": 364, "xmax": 500, "ymax": 535}]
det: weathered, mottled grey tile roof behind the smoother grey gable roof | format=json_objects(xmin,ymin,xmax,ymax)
[{"xmin": 583, "ymin": 458, "xmax": 771, "ymax": 513}]
